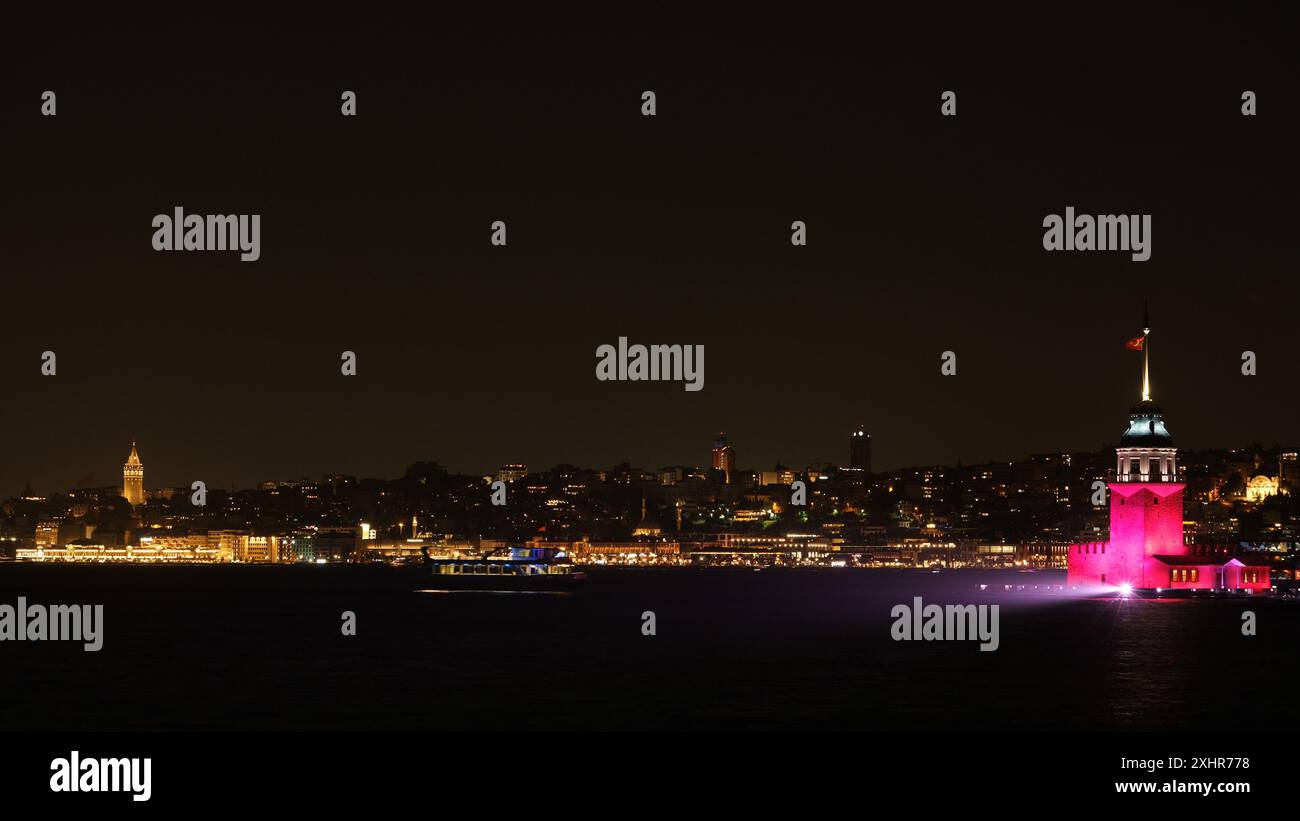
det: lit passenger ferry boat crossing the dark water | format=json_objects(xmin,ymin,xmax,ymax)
[{"xmin": 424, "ymin": 547, "xmax": 586, "ymax": 592}]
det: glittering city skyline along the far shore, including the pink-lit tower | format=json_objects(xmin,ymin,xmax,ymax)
[{"xmin": 12, "ymin": 327, "xmax": 1300, "ymax": 571}]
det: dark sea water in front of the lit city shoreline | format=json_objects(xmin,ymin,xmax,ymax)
[{"xmin": 0, "ymin": 564, "xmax": 1300, "ymax": 731}]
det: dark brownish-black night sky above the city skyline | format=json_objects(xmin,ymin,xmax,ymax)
[{"xmin": 0, "ymin": 6, "xmax": 1300, "ymax": 495}]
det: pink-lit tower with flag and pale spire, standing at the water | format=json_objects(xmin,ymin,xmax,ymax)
[{"xmin": 1067, "ymin": 310, "xmax": 1269, "ymax": 591}]
